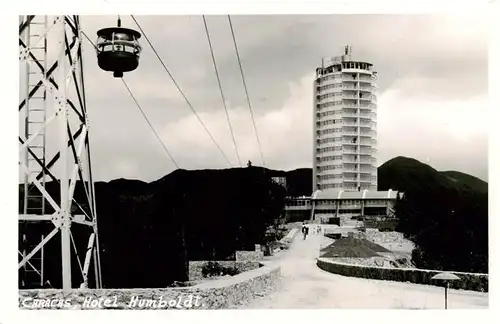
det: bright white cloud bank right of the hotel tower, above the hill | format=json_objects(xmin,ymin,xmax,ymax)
[{"xmin": 378, "ymin": 88, "xmax": 488, "ymax": 180}]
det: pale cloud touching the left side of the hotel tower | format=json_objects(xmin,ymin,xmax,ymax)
[{"xmin": 161, "ymin": 75, "xmax": 312, "ymax": 169}]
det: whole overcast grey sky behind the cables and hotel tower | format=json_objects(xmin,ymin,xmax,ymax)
[{"xmin": 19, "ymin": 15, "xmax": 488, "ymax": 181}]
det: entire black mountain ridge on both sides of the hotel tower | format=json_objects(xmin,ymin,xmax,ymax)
[{"xmin": 19, "ymin": 157, "xmax": 488, "ymax": 288}]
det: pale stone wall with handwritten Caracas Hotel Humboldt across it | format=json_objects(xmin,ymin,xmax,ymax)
[{"xmin": 19, "ymin": 265, "xmax": 281, "ymax": 310}]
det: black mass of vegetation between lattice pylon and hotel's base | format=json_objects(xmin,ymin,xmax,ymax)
[{"xmin": 20, "ymin": 167, "xmax": 285, "ymax": 288}]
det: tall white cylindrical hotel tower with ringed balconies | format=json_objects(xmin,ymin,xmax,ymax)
[{"xmin": 313, "ymin": 46, "xmax": 377, "ymax": 192}]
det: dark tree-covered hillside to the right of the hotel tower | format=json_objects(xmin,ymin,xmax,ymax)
[{"xmin": 378, "ymin": 157, "xmax": 488, "ymax": 273}]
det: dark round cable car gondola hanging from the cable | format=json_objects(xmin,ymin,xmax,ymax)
[{"xmin": 96, "ymin": 18, "xmax": 141, "ymax": 78}]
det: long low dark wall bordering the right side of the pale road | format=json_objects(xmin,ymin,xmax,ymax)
[{"xmin": 316, "ymin": 258, "xmax": 488, "ymax": 292}]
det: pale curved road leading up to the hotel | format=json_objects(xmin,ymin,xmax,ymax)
[{"xmin": 242, "ymin": 230, "xmax": 488, "ymax": 309}]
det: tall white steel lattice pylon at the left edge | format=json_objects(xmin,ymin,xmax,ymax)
[{"xmin": 18, "ymin": 16, "xmax": 102, "ymax": 290}]
